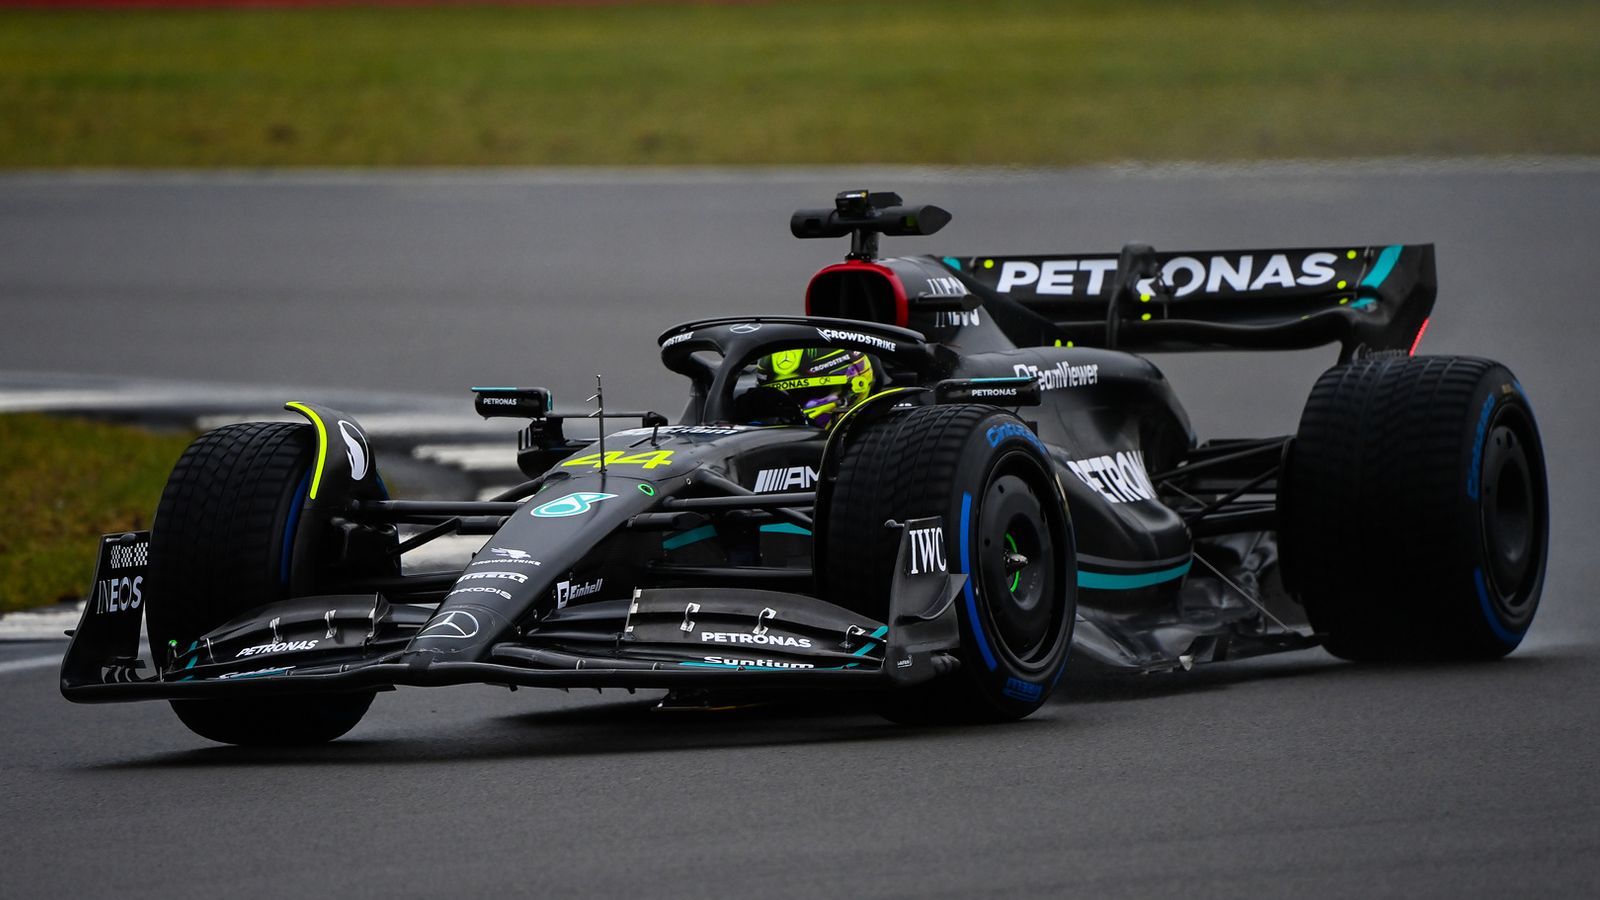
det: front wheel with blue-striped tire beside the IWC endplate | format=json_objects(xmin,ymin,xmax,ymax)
[{"xmin": 821, "ymin": 405, "xmax": 1077, "ymax": 722}]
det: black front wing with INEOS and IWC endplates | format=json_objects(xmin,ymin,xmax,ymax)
[{"xmin": 61, "ymin": 520, "xmax": 966, "ymax": 703}]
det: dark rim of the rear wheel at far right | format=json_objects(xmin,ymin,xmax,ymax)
[{"xmin": 1478, "ymin": 407, "xmax": 1546, "ymax": 617}]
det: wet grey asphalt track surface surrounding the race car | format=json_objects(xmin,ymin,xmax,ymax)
[{"xmin": 0, "ymin": 163, "xmax": 1600, "ymax": 898}]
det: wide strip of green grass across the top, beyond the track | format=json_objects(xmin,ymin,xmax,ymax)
[{"xmin": 0, "ymin": 0, "xmax": 1600, "ymax": 167}]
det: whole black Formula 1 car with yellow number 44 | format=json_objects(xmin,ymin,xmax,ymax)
[{"xmin": 62, "ymin": 191, "xmax": 1549, "ymax": 745}]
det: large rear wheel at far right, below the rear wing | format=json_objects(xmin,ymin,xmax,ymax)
[{"xmin": 1280, "ymin": 357, "xmax": 1549, "ymax": 660}]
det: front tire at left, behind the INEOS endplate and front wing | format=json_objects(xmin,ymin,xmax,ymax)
[{"xmin": 146, "ymin": 423, "xmax": 373, "ymax": 745}]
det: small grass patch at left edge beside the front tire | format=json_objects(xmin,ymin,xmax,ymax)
[{"xmin": 0, "ymin": 413, "xmax": 194, "ymax": 612}]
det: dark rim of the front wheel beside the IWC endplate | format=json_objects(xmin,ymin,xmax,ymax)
[{"xmin": 978, "ymin": 472, "xmax": 1059, "ymax": 663}]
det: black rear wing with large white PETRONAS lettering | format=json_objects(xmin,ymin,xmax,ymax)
[{"xmin": 940, "ymin": 243, "xmax": 1438, "ymax": 359}]
